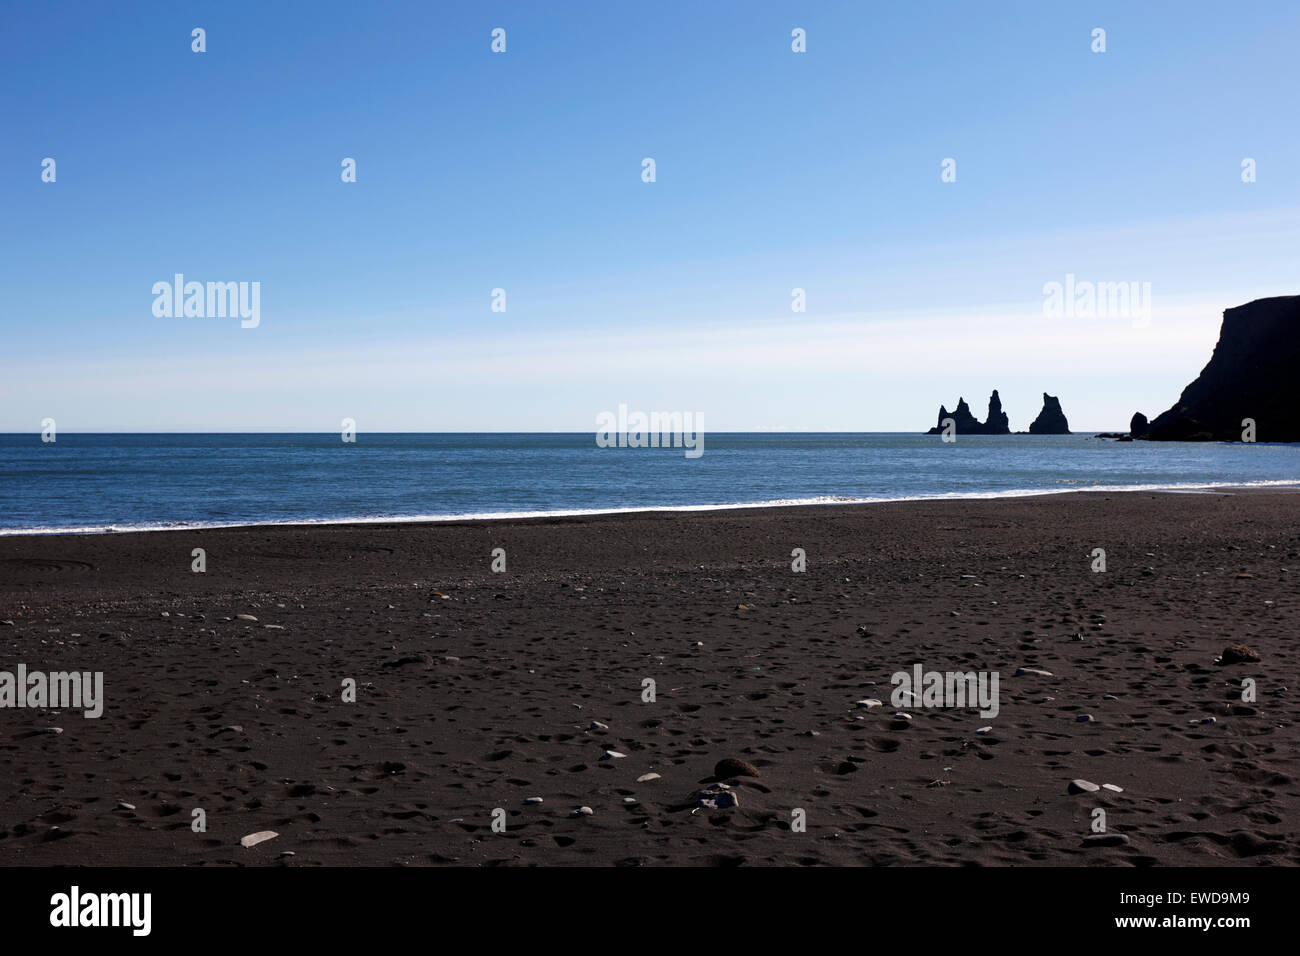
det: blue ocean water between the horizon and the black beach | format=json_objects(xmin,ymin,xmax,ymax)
[{"xmin": 0, "ymin": 432, "xmax": 1300, "ymax": 535}]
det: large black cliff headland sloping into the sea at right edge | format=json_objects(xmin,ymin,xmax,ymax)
[{"xmin": 1149, "ymin": 295, "xmax": 1300, "ymax": 441}]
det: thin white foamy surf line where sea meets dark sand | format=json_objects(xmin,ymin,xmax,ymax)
[{"xmin": 0, "ymin": 479, "xmax": 1300, "ymax": 540}]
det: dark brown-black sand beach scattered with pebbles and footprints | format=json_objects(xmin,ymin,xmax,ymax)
[{"xmin": 0, "ymin": 492, "xmax": 1300, "ymax": 866}]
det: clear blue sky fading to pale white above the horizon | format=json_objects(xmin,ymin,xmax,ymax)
[{"xmin": 0, "ymin": 0, "xmax": 1300, "ymax": 432}]
